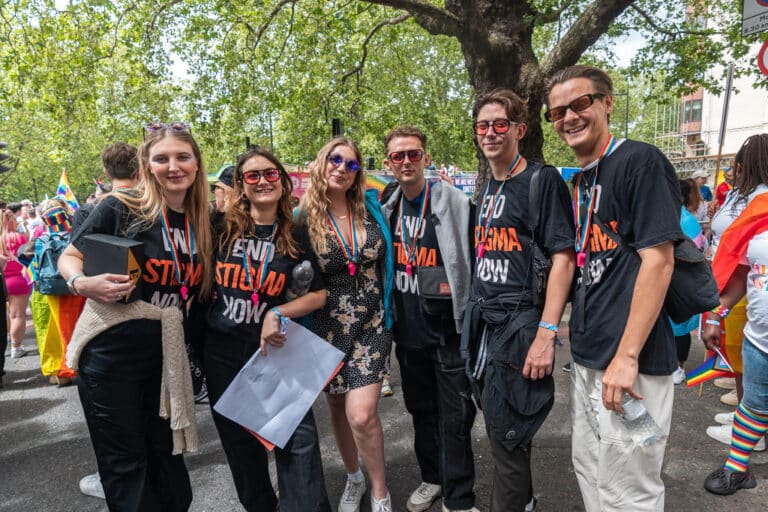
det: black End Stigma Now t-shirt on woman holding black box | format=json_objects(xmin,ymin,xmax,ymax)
[{"xmin": 72, "ymin": 197, "xmax": 203, "ymax": 307}]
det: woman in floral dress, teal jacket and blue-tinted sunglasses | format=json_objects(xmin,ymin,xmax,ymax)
[{"xmin": 298, "ymin": 137, "xmax": 394, "ymax": 512}]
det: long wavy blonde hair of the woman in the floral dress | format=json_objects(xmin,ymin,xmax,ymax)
[{"xmin": 299, "ymin": 137, "xmax": 365, "ymax": 254}]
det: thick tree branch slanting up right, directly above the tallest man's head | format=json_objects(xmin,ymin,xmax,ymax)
[{"xmin": 541, "ymin": 0, "xmax": 636, "ymax": 78}]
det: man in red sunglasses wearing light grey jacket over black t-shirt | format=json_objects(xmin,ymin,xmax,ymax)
[{"xmin": 382, "ymin": 126, "xmax": 477, "ymax": 512}]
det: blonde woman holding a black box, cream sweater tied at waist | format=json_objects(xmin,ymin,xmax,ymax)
[{"xmin": 58, "ymin": 125, "xmax": 213, "ymax": 512}]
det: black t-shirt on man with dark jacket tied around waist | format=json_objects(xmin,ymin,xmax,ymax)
[{"xmin": 471, "ymin": 162, "xmax": 574, "ymax": 303}]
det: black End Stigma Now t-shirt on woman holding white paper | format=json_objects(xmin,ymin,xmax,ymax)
[{"xmin": 208, "ymin": 225, "xmax": 325, "ymax": 345}]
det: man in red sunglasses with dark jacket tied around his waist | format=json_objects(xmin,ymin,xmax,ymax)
[{"xmin": 462, "ymin": 89, "xmax": 575, "ymax": 512}]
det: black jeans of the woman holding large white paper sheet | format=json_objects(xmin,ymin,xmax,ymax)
[{"xmin": 203, "ymin": 337, "xmax": 331, "ymax": 512}]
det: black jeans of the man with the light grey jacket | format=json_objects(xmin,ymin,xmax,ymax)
[{"xmin": 395, "ymin": 335, "xmax": 476, "ymax": 509}]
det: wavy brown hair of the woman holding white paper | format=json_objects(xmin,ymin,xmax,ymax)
[{"xmin": 218, "ymin": 146, "xmax": 299, "ymax": 259}]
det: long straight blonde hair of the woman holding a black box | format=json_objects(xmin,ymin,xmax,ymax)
[{"xmin": 111, "ymin": 128, "xmax": 213, "ymax": 299}]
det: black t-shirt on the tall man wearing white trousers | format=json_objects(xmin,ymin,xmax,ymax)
[{"xmin": 571, "ymin": 141, "xmax": 683, "ymax": 375}]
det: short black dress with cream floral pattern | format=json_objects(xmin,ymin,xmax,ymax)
[{"xmin": 313, "ymin": 211, "xmax": 392, "ymax": 394}]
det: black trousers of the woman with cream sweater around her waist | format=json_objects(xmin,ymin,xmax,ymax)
[{"xmin": 77, "ymin": 320, "xmax": 192, "ymax": 512}]
